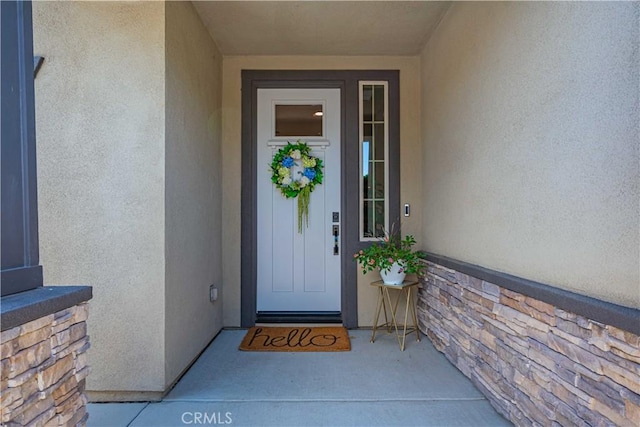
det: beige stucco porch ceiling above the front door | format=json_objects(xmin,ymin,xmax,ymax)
[{"xmin": 193, "ymin": 1, "xmax": 450, "ymax": 55}]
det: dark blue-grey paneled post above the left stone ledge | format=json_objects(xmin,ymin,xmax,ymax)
[{"xmin": 0, "ymin": 1, "xmax": 42, "ymax": 296}]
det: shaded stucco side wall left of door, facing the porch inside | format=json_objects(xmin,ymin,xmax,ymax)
[{"xmin": 165, "ymin": 2, "xmax": 222, "ymax": 386}]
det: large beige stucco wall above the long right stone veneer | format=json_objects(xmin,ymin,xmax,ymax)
[{"xmin": 421, "ymin": 2, "xmax": 640, "ymax": 307}]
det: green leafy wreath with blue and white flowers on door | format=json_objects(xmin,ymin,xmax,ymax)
[{"xmin": 271, "ymin": 140, "xmax": 322, "ymax": 233}]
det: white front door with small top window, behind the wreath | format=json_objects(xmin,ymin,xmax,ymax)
[{"xmin": 256, "ymin": 89, "xmax": 341, "ymax": 312}]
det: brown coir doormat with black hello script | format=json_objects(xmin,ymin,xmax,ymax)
[{"xmin": 240, "ymin": 326, "xmax": 351, "ymax": 351}]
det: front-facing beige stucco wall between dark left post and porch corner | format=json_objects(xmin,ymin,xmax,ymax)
[{"xmin": 33, "ymin": 2, "xmax": 165, "ymax": 391}]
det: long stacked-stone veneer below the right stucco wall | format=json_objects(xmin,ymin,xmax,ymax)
[{"xmin": 418, "ymin": 262, "xmax": 640, "ymax": 426}]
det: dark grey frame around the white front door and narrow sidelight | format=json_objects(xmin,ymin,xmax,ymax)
[{"xmin": 240, "ymin": 70, "xmax": 400, "ymax": 328}]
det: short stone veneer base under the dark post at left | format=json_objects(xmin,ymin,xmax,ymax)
[{"xmin": 0, "ymin": 303, "xmax": 89, "ymax": 426}]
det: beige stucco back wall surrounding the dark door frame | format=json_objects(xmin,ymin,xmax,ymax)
[{"xmin": 222, "ymin": 56, "xmax": 423, "ymax": 326}]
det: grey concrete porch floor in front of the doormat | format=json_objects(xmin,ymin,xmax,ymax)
[{"xmin": 88, "ymin": 330, "xmax": 511, "ymax": 427}]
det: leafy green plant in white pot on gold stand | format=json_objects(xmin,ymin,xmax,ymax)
[{"xmin": 353, "ymin": 231, "xmax": 424, "ymax": 285}]
